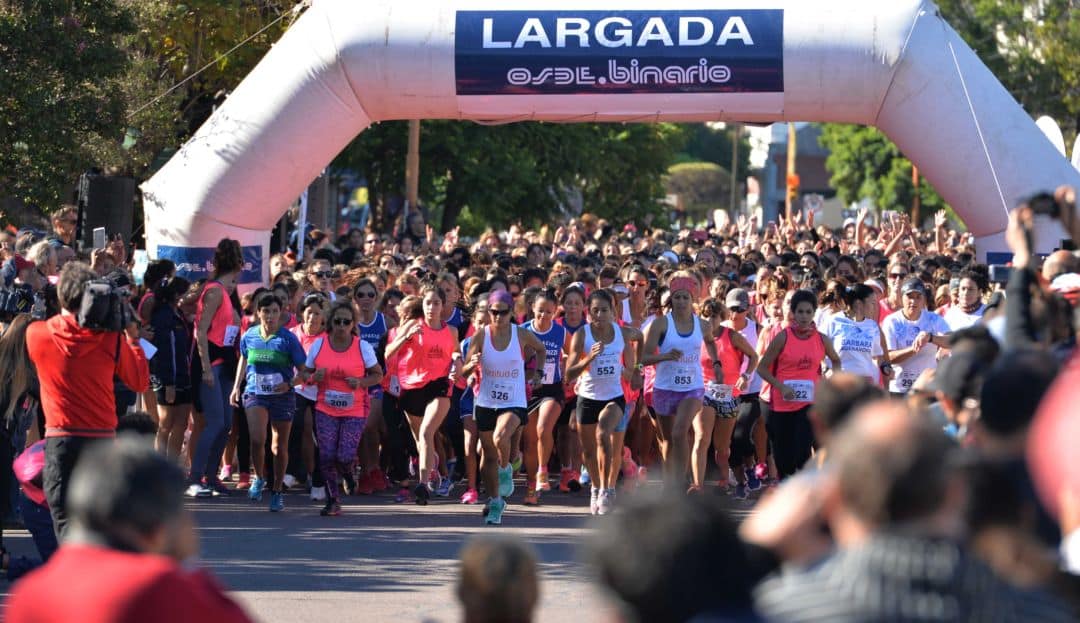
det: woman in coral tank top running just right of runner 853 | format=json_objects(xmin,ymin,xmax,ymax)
[{"xmin": 690, "ymin": 299, "xmax": 757, "ymax": 492}]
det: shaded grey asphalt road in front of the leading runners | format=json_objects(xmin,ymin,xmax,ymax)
[{"xmin": 0, "ymin": 479, "xmax": 748, "ymax": 623}]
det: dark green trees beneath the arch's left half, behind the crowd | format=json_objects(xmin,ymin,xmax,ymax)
[{"xmin": 335, "ymin": 121, "xmax": 681, "ymax": 234}]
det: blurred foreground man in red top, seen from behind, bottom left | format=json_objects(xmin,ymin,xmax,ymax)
[{"xmin": 5, "ymin": 435, "xmax": 251, "ymax": 623}]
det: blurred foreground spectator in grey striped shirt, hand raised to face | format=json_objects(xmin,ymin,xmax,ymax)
[{"xmin": 742, "ymin": 403, "xmax": 1072, "ymax": 622}]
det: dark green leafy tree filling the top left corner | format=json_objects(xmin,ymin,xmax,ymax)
[{"xmin": 0, "ymin": 0, "xmax": 135, "ymax": 208}]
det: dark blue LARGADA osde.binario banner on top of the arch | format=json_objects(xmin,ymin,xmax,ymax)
[{"xmin": 455, "ymin": 10, "xmax": 784, "ymax": 95}]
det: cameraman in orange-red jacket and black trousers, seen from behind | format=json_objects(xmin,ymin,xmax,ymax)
[{"xmin": 26, "ymin": 262, "xmax": 150, "ymax": 538}]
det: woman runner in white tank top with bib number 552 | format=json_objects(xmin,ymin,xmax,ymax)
[{"xmin": 566, "ymin": 289, "xmax": 639, "ymax": 515}]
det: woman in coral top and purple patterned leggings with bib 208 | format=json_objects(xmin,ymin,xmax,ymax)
[{"xmin": 303, "ymin": 301, "xmax": 382, "ymax": 517}]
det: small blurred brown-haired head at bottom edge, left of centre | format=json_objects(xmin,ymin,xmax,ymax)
[{"xmin": 457, "ymin": 537, "xmax": 540, "ymax": 623}]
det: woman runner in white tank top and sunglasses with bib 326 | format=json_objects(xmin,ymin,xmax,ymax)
[{"xmin": 461, "ymin": 290, "xmax": 546, "ymax": 525}]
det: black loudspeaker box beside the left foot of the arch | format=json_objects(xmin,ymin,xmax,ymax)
[{"xmin": 78, "ymin": 174, "xmax": 135, "ymax": 248}]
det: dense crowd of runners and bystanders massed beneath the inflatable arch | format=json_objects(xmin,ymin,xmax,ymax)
[{"xmin": 0, "ymin": 190, "xmax": 1080, "ymax": 617}]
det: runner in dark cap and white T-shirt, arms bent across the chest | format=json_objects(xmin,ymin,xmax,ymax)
[{"xmin": 881, "ymin": 276, "xmax": 949, "ymax": 395}]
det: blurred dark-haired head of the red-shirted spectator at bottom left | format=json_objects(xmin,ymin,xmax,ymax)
[{"xmin": 68, "ymin": 435, "xmax": 197, "ymax": 560}]
